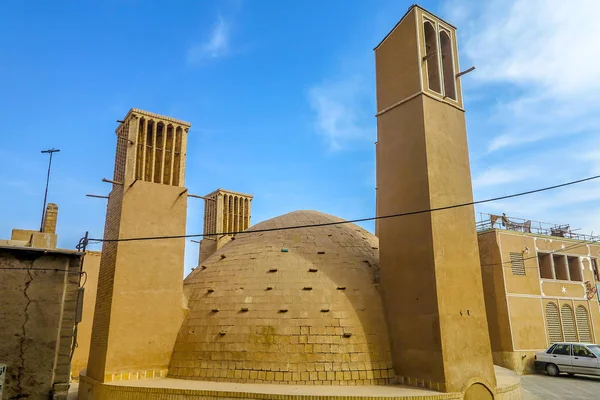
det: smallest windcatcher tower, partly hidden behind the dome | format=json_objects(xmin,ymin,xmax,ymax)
[{"xmin": 198, "ymin": 189, "xmax": 253, "ymax": 264}]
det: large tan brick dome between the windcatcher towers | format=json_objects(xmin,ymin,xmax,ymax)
[{"xmin": 169, "ymin": 211, "xmax": 393, "ymax": 384}]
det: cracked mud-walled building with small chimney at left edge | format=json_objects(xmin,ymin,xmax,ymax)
[{"xmin": 0, "ymin": 204, "xmax": 84, "ymax": 400}]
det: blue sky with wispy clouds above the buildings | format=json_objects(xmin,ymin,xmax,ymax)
[{"xmin": 0, "ymin": 0, "xmax": 600, "ymax": 269}]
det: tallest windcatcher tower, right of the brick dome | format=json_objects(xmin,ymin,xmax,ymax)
[{"xmin": 375, "ymin": 6, "xmax": 496, "ymax": 399}]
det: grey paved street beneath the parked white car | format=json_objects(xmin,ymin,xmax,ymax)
[{"xmin": 521, "ymin": 374, "xmax": 600, "ymax": 400}]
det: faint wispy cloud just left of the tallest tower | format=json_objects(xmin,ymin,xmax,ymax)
[{"xmin": 308, "ymin": 75, "xmax": 375, "ymax": 150}]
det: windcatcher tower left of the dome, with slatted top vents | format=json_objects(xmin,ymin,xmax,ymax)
[{"xmin": 87, "ymin": 109, "xmax": 190, "ymax": 382}]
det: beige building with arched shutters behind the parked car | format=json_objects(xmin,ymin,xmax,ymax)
[{"xmin": 478, "ymin": 215, "xmax": 600, "ymax": 372}]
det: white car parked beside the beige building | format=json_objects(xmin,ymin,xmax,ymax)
[{"xmin": 535, "ymin": 342, "xmax": 600, "ymax": 376}]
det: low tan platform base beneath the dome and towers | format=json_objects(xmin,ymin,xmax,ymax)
[{"xmin": 78, "ymin": 367, "xmax": 522, "ymax": 400}]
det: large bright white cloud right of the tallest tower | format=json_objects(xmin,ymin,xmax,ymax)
[{"xmin": 445, "ymin": 0, "xmax": 600, "ymax": 152}]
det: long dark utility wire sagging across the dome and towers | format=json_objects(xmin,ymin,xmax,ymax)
[{"xmin": 89, "ymin": 175, "xmax": 600, "ymax": 243}]
